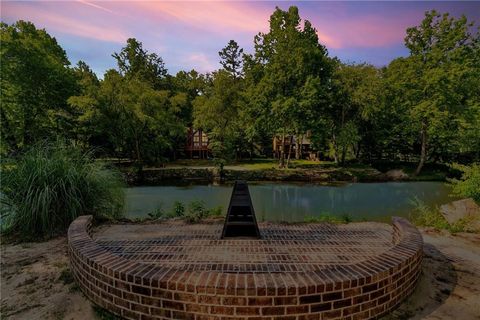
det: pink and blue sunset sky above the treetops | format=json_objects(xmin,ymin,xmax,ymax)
[{"xmin": 1, "ymin": 0, "xmax": 480, "ymax": 77}]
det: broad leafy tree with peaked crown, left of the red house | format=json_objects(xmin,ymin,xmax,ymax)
[{"xmin": 68, "ymin": 39, "xmax": 187, "ymax": 164}]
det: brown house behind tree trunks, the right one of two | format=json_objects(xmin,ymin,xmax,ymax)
[{"xmin": 273, "ymin": 133, "xmax": 317, "ymax": 160}]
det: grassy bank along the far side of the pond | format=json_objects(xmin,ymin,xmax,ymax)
[{"xmin": 121, "ymin": 159, "xmax": 449, "ymax": 185}]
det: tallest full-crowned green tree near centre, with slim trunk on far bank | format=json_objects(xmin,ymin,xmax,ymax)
[{"xmin": 246, "ymin": 6, "xmax": 332, "ymax": 167}]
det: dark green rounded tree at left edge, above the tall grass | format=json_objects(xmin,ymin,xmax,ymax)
[{"xmin": 0, "ymin": 21, "xmax": 76, "ymax": 153}]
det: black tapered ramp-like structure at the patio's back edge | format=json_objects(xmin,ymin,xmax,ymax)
[{"xmin": 222, "ymin": 181, "xmax": 260, "ymax": 239}]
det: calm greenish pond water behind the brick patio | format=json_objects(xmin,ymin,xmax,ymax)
[{"xmin": 125, "ymin": 182, "xmax": 454, "ymax": 222}]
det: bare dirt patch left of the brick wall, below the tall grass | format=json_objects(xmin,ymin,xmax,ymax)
[{"xmin": 0, "ymin": 237, "xmax": 96, "ymax": 320}]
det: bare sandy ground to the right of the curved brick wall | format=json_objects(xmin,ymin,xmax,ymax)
[{"xmin": 384, "ymin": 229, "xmax": 480, "ymax": 320}]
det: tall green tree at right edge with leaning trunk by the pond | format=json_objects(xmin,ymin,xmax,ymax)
[{"xmin": 400, "ymin": 11, "xmax": 479, "ymax": 174}]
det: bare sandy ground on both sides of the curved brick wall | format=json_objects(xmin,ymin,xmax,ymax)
[{"xmin": 0, "ymin": 229, "xmax": 480, "ymax": 320}]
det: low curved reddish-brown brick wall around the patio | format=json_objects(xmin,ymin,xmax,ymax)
[{"xmin": 68, "ymin": 216, "xmax": 423, "ymax": 320}]
